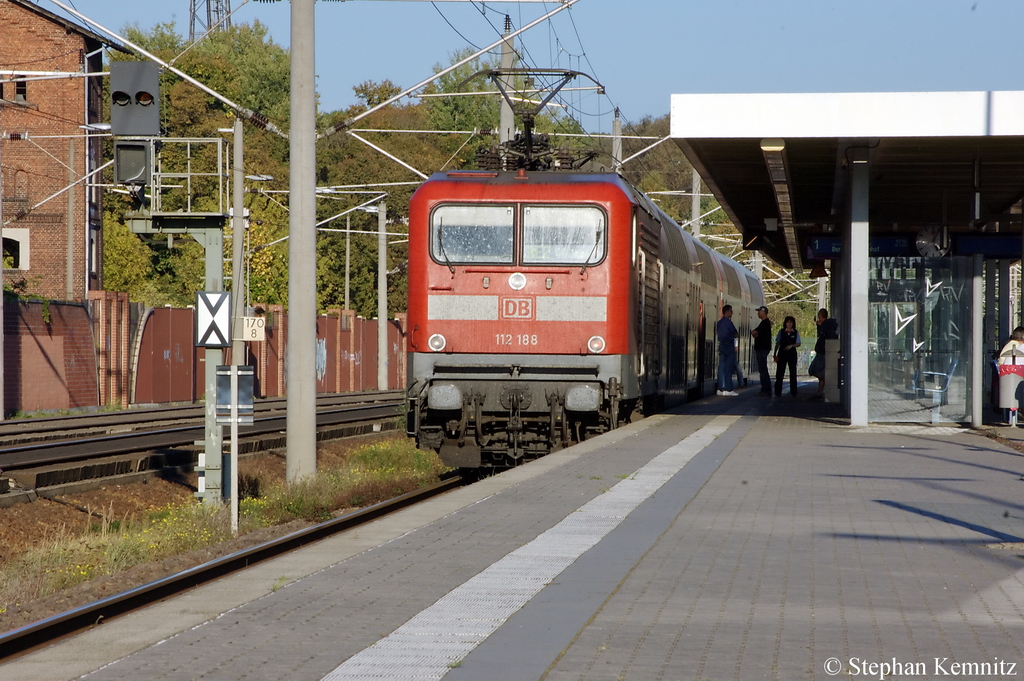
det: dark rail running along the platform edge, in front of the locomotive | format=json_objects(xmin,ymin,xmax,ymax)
[{"xmin": 0, "ymin": 476, "xmax": 464, "ymax": 663}]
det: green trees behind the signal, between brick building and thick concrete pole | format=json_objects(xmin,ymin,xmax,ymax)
[{"xmin": 103, "ymin": 22, "xmax": 290, "ymax": 305}]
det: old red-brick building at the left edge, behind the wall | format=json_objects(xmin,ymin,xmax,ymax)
[{"xmin": 0, "ymin": 0, "xmax": 128, "ymax": 300}]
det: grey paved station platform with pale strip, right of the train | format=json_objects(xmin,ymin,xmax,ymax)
[{"xmin": 0, "ymin": 382, "xmax": 1024, "ymax": 681}]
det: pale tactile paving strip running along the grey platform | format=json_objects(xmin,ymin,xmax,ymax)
[{"xmin": 324, "ymin": 416, "xmax": 738, "ymax": 681}]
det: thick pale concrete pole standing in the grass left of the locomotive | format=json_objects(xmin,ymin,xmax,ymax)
[{"xmin": 286, "ymin": 0, "xmax": 316, "ymax": 482}]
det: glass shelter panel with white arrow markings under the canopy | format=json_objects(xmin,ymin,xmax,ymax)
[{"xmin": 867, "ymin": 257, "xmax": 973, "ymax": 423}]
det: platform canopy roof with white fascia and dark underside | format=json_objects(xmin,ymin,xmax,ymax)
[{"xmin": 671, "ymin": 91, "xmax": 1024, "ymax": 266}]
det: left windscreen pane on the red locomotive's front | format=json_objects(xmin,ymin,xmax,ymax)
[{"xmin": 430, "ymin": 206, "xmax": 515, "ymax": 265}]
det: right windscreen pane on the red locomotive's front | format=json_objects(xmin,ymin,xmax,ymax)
[{"xmin": 522, "ymin": 206, "xmax": 607, "ymax": 265}]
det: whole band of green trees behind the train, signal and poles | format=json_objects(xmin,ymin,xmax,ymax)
[{"xmin": 103, "ymin": 22, "xmax": 815, "ymax": 329}]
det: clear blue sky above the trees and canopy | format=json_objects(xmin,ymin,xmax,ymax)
[{"xmin": 44, "ymin": 0, "xmax": 1024, "ymax": 132}]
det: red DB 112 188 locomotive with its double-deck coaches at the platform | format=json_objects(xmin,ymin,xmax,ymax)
[{"xmin": 409, "ymin": 170, "xmax": 764, "ymax": 468}]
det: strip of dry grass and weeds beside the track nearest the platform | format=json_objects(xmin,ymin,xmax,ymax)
[{"xmin": 0, "ymin": 438, "xmax": 446, "ymax": 614}]
